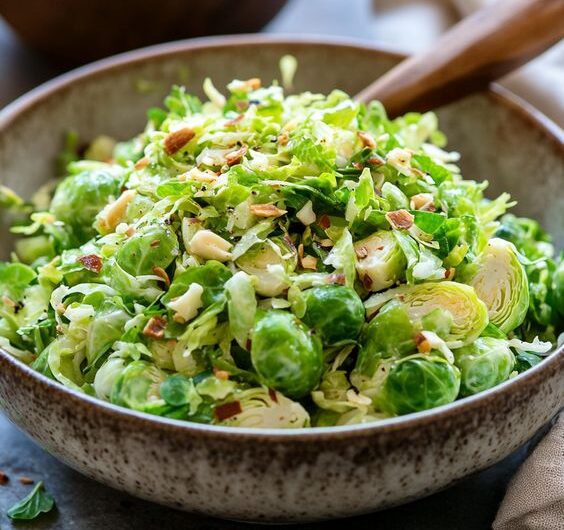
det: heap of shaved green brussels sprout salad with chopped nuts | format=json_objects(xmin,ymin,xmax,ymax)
[{"xmin": 0, "ymin": 67, "xmax": 564, "ymax": 428}]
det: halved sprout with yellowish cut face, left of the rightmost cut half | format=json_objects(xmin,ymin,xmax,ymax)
[{"xmin": 364, "ymin": 281, "xmax": 488, "ymax": 346}]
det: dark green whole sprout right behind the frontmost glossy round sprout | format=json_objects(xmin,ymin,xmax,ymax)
[{"xmin": 302, "ymin": 285, "xmax": 364, "ymax": 345}]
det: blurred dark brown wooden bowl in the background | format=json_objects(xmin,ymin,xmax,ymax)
[{"xmin": 0, "ymin": 0, "xmax": 286, "ymax": 66}]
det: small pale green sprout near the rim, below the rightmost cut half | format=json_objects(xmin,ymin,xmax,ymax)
[{"xmin": 454, "ymin": 337, "xmax": 515, "ymax": 396}]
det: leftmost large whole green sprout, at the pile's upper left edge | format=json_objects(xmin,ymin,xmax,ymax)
[{"xmin": 51, "ymin": 169, "xmax": 120, "ymax": 243}]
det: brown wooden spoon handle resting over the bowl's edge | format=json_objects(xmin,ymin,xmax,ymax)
[{"xmin": 355, "ymin": 0, "xmax": 564, "ymax": 117}]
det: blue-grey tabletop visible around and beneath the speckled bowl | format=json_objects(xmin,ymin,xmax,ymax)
[{"xmin": 0, "ymin": 0, "xmax": 548, "ymax": 530}]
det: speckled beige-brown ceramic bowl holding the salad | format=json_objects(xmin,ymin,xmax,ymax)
[{"xmin": 0, "ymin": 37, "xmax": 564, "ymax": 522}]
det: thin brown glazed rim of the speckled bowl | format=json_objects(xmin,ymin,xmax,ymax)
[{"xmin": 0, "ymin": 35, "xmax": 564, "ymax": 442}]
